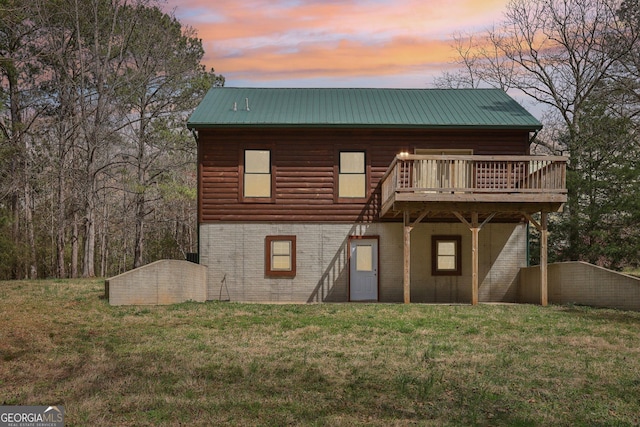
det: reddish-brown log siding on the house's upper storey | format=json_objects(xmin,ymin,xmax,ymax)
[{"xmin": 198, "ymin": 128, "xmax": 529, "ymax": 223}]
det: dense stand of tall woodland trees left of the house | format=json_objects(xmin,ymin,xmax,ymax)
[{"xmin": 0, "ymin": 0, "xmax": 224, "ymax": 278}]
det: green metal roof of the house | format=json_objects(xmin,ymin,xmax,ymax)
[{"xmin": 187, "ymin": 87, "xmax": 542, "ymax": 130}]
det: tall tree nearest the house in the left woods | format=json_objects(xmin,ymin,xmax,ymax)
[{"xmin": 118, "ymin": 6, "xmax": 222, "ymax": 267}]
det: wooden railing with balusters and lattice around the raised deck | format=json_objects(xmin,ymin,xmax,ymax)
[{"xmin": 382, "ymin": 154, "xmax": 567, "ymax": 206}]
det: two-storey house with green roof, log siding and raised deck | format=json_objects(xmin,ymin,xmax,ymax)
[{"xmin": 188, "ymin": 88, "xmax": 567, "ymax": 304}]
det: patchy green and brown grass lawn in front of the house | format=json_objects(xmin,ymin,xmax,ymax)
[{"xmin": 0, "ymin": 280, "xmax": 640, "ymax": 426}]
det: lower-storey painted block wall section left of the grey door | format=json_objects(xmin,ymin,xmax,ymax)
[{"xmin": 200, "ymin": 223, "xmax": 356, "ymax": 302}]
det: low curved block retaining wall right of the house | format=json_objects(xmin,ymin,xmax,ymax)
[{"xmin": 518, "ymin": 262, "xmax": 640, "ymax": 311}]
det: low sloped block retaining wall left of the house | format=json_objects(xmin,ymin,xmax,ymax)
[{"xmin": 105, "ymin": 260, "xmax": 207, "ymax": 305}]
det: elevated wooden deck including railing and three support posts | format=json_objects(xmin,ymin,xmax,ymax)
[{"xmin": 380, "ymin": 154, "xmax": 567, "ymax": 306}]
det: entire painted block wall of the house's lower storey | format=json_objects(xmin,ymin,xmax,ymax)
[{"xmin": 200, "ymin": 223, "xmax": 526, "ymax": 303}]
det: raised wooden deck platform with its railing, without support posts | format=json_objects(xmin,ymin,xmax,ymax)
[{"xmin": 380, "ymin": 154, "xmax": 567, "ymax": 218}]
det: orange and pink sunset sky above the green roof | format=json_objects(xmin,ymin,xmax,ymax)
[{"xmin": 166, "ymin": 0, "xmax": 508, "ymax": 88}]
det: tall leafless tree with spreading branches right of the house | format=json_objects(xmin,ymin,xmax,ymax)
[{"xmin": 432, "ymin": 0, "xmax": 638, "ymax": 259}]
